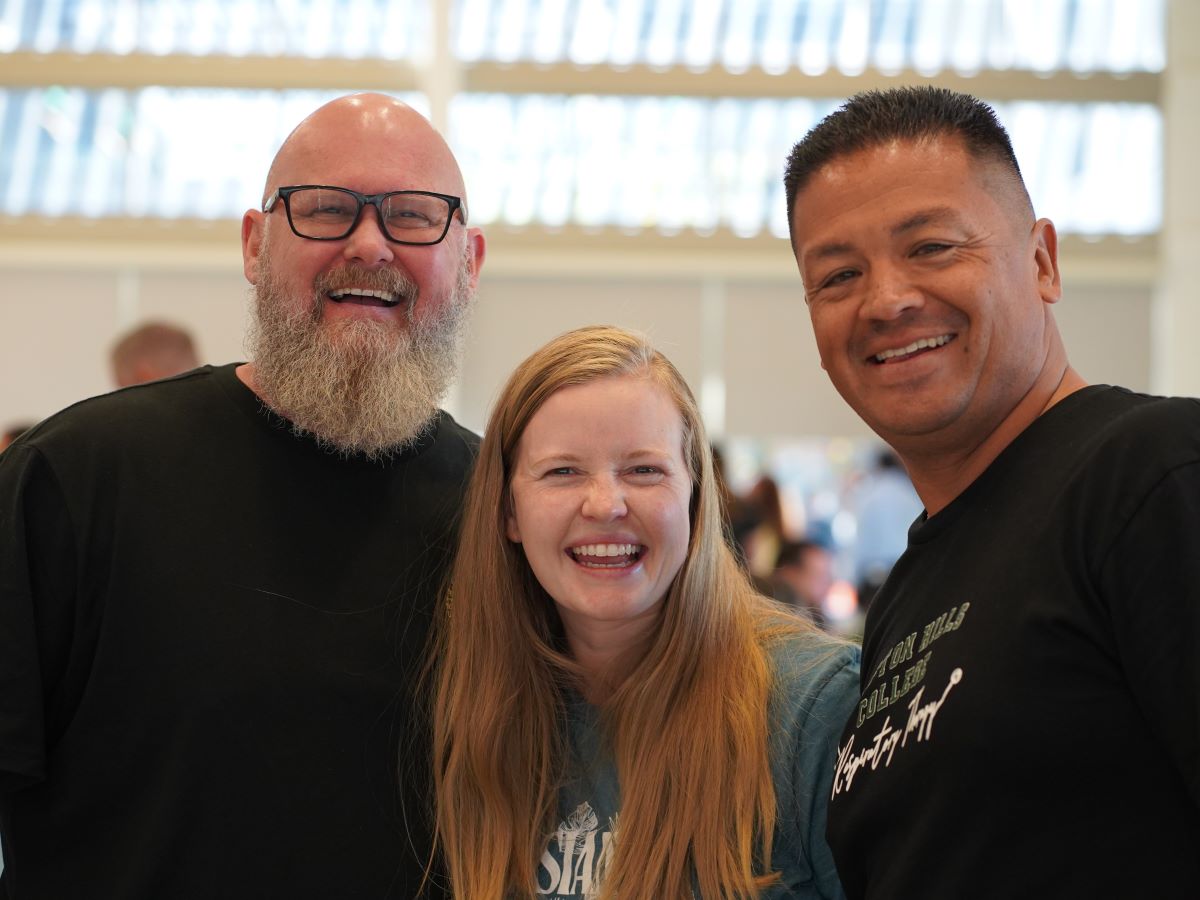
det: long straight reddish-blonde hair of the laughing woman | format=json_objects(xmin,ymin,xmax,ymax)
[{"xmin": 433, "ymin": 326, "xmax": 814, "ymax": 900}]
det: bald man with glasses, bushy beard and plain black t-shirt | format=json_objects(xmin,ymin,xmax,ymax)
[{"xmin": 0, "ymin": 94, "xmax": 484, "ymax": 900}]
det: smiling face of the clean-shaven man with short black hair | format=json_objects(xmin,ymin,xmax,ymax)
[{"xmin": 792, "ymin": 137, "xmax": 1060, "ymax": 450}]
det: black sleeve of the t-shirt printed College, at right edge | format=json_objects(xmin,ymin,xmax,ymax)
[{"xmin": 1100, "ymin": 462, "xmax": 1200, "ymax": 808}]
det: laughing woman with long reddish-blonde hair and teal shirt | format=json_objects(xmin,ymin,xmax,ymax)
[{"xmin": 433, "ymin": 326, "xmax": 858, "ymax": 900}]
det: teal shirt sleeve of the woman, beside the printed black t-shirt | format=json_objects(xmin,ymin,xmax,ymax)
[{"xmin": 781, "ymin": 647, "xmax": 860, "ymax": 899}]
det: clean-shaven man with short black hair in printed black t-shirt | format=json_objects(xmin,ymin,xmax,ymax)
[{"xmin": 786, "ymin": 88, "xmax": 1200, "ymax": 900}]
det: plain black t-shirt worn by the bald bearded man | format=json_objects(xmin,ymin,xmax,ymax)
[{"xmin": 0, "ymin": 366, "xmax": 478, "ymax": 900}]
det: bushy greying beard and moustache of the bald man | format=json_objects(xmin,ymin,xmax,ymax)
[{"xmin": 246, "ymin": 247, "xmax": 473, "ymax": 460}]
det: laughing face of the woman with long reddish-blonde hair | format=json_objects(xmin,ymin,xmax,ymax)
[{"xmin": 506, "ymin": 374, "xmax": 692, "ymax": 646}]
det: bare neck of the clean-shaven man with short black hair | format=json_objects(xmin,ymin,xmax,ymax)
[{"xmin": 895, "ymin": 360, "xmax": 1087, "ymax": 516}]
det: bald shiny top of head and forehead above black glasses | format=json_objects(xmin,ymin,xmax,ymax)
[{"xmin": 263, "ymin": 94, "xmax": 467, "ymax": 218}]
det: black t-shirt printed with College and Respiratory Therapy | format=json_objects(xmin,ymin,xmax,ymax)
[{"xmin": 828, "ymin": 386, "xmax": 1200, "ymax": 900}]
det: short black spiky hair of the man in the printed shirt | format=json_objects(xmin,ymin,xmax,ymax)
[{"xmin": 784, "ymin": 86, "xmax": 1028, "ymax": 241}]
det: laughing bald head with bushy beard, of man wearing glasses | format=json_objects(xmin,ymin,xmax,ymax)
[{"xmin": 239, "ymin": 94, "xmax": 484, "ymax": 456}]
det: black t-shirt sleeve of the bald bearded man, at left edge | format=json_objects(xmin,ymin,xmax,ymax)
[{"xmin": 0, "ymin": 443, "xmax": 74, "ymax": 791}]
